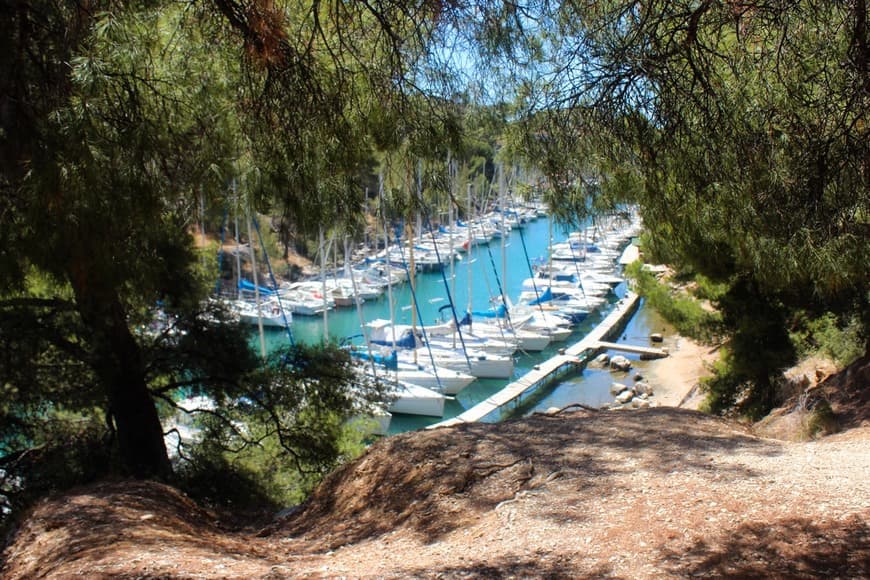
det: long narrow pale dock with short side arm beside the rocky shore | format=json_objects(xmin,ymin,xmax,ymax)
[{"xmin": 427, "ymin": 291, "xmax": 667, "ymax": 429}]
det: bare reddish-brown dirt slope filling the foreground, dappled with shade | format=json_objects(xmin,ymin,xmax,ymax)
[{"xmin": 3, "ymin": 408, "xmax": 870, "ymax": 578}]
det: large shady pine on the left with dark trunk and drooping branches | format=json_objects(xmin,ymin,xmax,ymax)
[{"xmin": 0, "ymin": 0, "xmax": 450, "ymax": 508}]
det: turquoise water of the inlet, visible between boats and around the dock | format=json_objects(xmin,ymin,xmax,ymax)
[{"xmin": 252, "ymin": 218, "xmax": 648, "ymax": 433}]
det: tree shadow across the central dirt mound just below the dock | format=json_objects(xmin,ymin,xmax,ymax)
[{"xmin": 280, "ymin": 408, "xmax": 781, "ymax": 549}]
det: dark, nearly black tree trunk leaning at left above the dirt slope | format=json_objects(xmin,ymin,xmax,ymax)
[{"xmin": 73, "ymin": 266, "xmax": 172, "ymax": 478}]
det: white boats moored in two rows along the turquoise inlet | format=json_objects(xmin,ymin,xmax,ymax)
[{"xmin": 221, "ymin": 204, "xmax": 639, "ymax": 426}]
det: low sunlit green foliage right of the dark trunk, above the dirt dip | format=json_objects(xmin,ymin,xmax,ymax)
[{"xmin": 168, "ymin": 344, "xmax": 386, "ymax": 507}]
